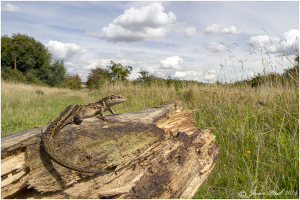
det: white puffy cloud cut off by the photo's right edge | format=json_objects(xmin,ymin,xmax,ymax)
[{"xmin": 247, "ymin": 29, "xmax": 300, "ymax": 54}]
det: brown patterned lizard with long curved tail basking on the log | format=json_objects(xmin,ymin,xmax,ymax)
[{"xmin": 43, "ymin": 95, "xmax": 127, "ymax": 173}]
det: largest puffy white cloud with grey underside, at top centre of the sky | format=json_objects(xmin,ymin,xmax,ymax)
[{"xmin": 100, "ymin": 2, "xmax": 176, "ymax": 42}]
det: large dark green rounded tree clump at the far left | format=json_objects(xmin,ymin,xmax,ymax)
[{"xmin": 1, "ymin": 33, "xmax": 66, "ymax": 86}]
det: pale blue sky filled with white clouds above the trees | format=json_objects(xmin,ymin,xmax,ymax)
[{"xmin": 1, "ymin": 1, "xmax": 300, "ymax": 82}]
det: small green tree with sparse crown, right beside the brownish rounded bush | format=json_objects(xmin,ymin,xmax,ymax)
[{"xmin": 106, "ymin": 61, "xmax": 132, "ymax": 81}]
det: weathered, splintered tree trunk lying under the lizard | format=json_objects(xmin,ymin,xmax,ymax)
[{"xmin": 1, "ymin": 101, "xmax": 219, "ymax": 199}]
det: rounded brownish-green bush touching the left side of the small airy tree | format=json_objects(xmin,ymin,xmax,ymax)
[{"xmin": 86, "ymin": 65, "xmax": 110, "ymax": 89}]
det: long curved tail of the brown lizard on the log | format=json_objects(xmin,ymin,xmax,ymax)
[{"xmin": 43, "ymin": 134, "xmax": 117, "ymax": 174}]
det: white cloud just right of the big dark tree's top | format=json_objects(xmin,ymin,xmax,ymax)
[{"xmin": 46, "ymin": 40, "xmax": 88, "ymax": 58}]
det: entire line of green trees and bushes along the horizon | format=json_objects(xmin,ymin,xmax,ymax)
[{"xmin": 1, "ymin": 33, "xmax": 299, "ymax": 90}]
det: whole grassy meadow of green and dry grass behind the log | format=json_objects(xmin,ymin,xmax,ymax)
[{"xmin": 1, "ymin": 74, "xmax": 299, "ymax": 198}]
